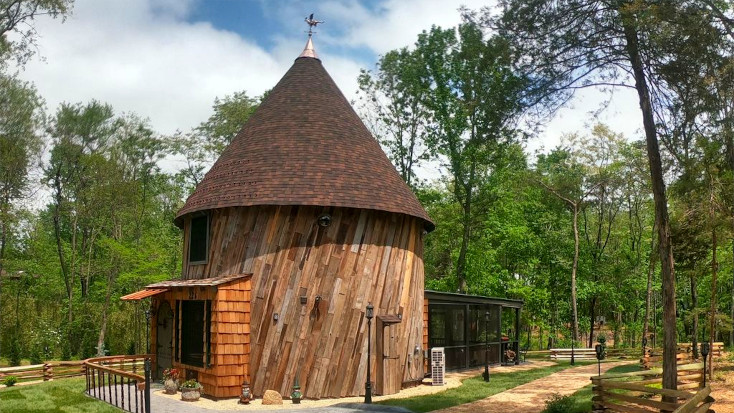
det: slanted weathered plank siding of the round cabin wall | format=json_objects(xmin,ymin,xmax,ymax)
[{"xmin": 183, "ymin": 206, "xmax": 424, "ymax": 398}]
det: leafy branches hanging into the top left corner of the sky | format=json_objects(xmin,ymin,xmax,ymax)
[{"xmin": 0, "ymin": 0, "xmax": 73, "ymax": 66}]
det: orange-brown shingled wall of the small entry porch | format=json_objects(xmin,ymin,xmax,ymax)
[{"xmin": 151, "ymin": 278, "xmax": 252, "ymax": 397}]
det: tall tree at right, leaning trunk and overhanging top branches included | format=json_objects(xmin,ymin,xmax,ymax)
[{"xmin": 485, "ymin": 0, "xmax": 732, "ymax": 389}]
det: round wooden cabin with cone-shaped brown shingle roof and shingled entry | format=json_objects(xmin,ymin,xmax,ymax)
[{"xmin": 149, "ymin": 38, "xmax": 433, "ymax": 398}]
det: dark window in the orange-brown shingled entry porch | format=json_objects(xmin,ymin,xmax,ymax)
[{"xmin": 178, "ymin": 301, "xmax": 211, "ymax": 367}]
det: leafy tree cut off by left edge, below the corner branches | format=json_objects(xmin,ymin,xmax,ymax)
[{"xmin": 0, "ymin": 75, "xmax": 45, "ymax": 358}]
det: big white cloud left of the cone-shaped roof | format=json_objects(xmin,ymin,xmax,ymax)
[{"xmin": 22, "ymin": 0, "xmax": 289, "ymax": 133}]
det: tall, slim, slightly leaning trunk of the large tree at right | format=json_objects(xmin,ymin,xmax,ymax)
[{"xmin": 620, "ymin": 6, "xmax": 678, "ymax": 390}]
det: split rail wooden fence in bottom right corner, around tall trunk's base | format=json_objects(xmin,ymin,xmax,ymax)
[{"xmin": 591, "ymin": 363, "xmax": 714, "ymax": 413}]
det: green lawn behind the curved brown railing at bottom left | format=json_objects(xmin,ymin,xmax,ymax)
[{"xmin": 0, "ymin": 378, "xmax": 120, "ymax": 413}]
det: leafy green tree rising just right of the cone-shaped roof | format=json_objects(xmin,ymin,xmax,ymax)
[{"xmin": 415, "ymin": 14, "xmax": 524, "ymax": 291}]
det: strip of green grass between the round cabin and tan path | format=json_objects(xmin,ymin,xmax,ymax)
[{"xmin": 378, "ymin": 362, "xmax": 593, "ymax": 413}]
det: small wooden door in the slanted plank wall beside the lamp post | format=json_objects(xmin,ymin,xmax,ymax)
[{"xmin": 375, "ymin": 316, "xmax": 403, "ymax": 395}]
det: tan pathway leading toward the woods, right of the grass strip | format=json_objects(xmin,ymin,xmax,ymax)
[{"xmin": 434, "ymin": 361, "xmax": 631, "ymax": 413}]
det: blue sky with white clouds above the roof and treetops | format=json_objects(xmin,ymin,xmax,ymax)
[{"xmin": 14, "ymin": 0, "xmax": 641, "ymax": 171}]
